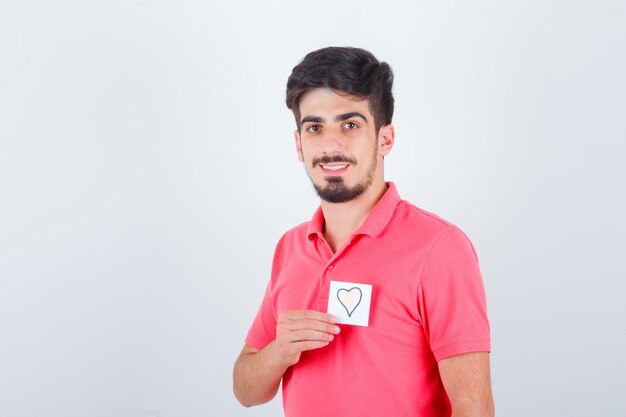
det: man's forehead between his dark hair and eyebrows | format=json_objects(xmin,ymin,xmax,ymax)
[{"xmin": 299, "ymin": 88, "xmax": 371, "ymax": 118}]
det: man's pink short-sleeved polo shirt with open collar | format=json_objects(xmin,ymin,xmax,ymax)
[{"xmin": 246, "ymin": 183, "xmax": 490, "ymax": 417}]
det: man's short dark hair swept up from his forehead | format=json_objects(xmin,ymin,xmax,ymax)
[{"xmin": 286, "ymin": 47, "xmax": 393, "ymax": 131}]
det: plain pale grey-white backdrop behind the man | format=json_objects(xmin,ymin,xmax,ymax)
[{"xmin": 0, "ymin": 0, "xmax": 626, "ymax": 417}]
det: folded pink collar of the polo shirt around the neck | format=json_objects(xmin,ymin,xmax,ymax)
[{"xmin": 307, "ymin": 182, "xmax": 400, "ymax": 240}]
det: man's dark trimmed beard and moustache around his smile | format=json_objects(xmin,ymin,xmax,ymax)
[{"xmin": 309, "ymin": 152, "xmax": 378, "ymax": 203}]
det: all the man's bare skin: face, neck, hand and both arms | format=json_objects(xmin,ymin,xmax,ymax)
[{"xmin": 233, "ymin": 88, "xmax": 493, "ymax": 417}]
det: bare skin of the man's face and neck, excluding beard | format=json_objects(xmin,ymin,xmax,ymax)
[{"xmin": 294, "ymin": 88, "xmax": 395, "ymax": 251}]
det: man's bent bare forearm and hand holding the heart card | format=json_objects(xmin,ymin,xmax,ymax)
[{"xmin": 233, "ymin": 310, "xmax": 339, "ymax": 407}]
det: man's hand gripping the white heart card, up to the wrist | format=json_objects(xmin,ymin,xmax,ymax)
[{"xmin": 276, "ymin": 310, "xmax": 339, "ymax": 366}]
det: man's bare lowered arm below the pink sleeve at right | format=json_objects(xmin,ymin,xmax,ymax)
[{"xmin": 439, "ymin": 352, "xmax": 494, "ymax": 417}]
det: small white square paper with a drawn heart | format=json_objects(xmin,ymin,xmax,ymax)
[{"xmin": 328, "ymin": 281, "xmax": 372, "ymax": 327}]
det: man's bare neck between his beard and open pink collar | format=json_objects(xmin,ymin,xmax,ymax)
[{"xmin": 321, "ymin": 180, "xmax": 387, "ymax": 252}]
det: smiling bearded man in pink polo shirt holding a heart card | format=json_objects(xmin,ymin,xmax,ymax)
[{"xmin": 233, "ymin": 48, "xmax": 493, "ymax": 417}]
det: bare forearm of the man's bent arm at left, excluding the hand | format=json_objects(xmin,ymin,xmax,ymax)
[{"xmin": 233, "ymin": 340, "xmax": 289, "ymax": 407}]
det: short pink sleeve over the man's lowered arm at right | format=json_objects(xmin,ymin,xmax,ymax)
[{"xmin": 418, "ymin": 225, "xmax": 491, "ymax": 361}]
